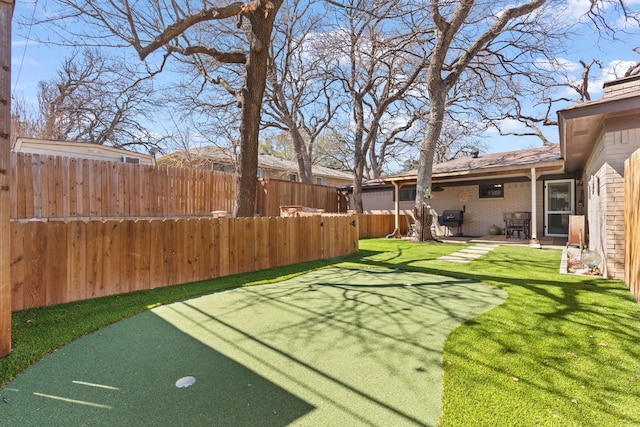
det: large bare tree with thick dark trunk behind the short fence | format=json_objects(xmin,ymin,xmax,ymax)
[{"xmin": 47, "ymin": 0, "xmax": 282, "ymax": 217}]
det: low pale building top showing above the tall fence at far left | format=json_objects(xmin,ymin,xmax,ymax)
[{"xmin": 11, "ymin": 138, "xmax": 154, "ymax": 165}]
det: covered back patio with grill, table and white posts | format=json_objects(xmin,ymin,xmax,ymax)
[{"xmin": 370, "ymin": 145, "xmax": 583, "ymax": 247}]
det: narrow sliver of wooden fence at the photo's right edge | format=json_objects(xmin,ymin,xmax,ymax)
[{"xmin": 624, "ymin": 150, "xmax": 640, "ymax": 303}]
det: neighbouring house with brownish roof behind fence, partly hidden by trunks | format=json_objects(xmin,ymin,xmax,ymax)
[{"xmin": 158, "ymin": 146, "xmax": 353, "ymax": 187}]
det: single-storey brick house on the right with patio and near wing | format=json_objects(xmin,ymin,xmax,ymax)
[{"xmin": 356, "ymin": 76, "xmax": 640, "ymax": 279}]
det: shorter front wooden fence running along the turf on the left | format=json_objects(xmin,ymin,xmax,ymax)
[{"xmin": 10, "ymin": 215, "xmax": 358, "ymax": 311}]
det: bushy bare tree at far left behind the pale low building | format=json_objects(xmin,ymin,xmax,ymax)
[{"xmin": 31, "ymin": 49, "xmax": 158, "ymax": 151}]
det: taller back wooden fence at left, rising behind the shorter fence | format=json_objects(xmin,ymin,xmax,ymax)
[{"xmin": 11, "ymin": 153, "xmax": 236, "ymax": 219}]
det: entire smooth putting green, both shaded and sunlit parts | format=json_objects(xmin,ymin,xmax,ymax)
[{"xmin": 2, "ymin": 268, "xmax": 506, "ymax": 427}]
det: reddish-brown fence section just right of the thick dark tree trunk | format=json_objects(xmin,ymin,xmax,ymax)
[{"xmin": 256, "ymin": 178, "xmax": 347, "ymax": 216}]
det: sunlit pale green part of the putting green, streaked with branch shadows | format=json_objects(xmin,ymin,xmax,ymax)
[{"xmin": 154, "ymin": 268, "xmax": 504, "ymax": 425}]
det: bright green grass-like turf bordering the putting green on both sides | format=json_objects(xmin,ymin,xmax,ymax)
[{"xmin": 0, "ymin": 239, "xmax": 640, "ymax": 426}]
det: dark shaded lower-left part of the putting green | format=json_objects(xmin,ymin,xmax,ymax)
[{"xmin": 0, "ymin": 312, "xmax": 314, "ymax": 427}]
